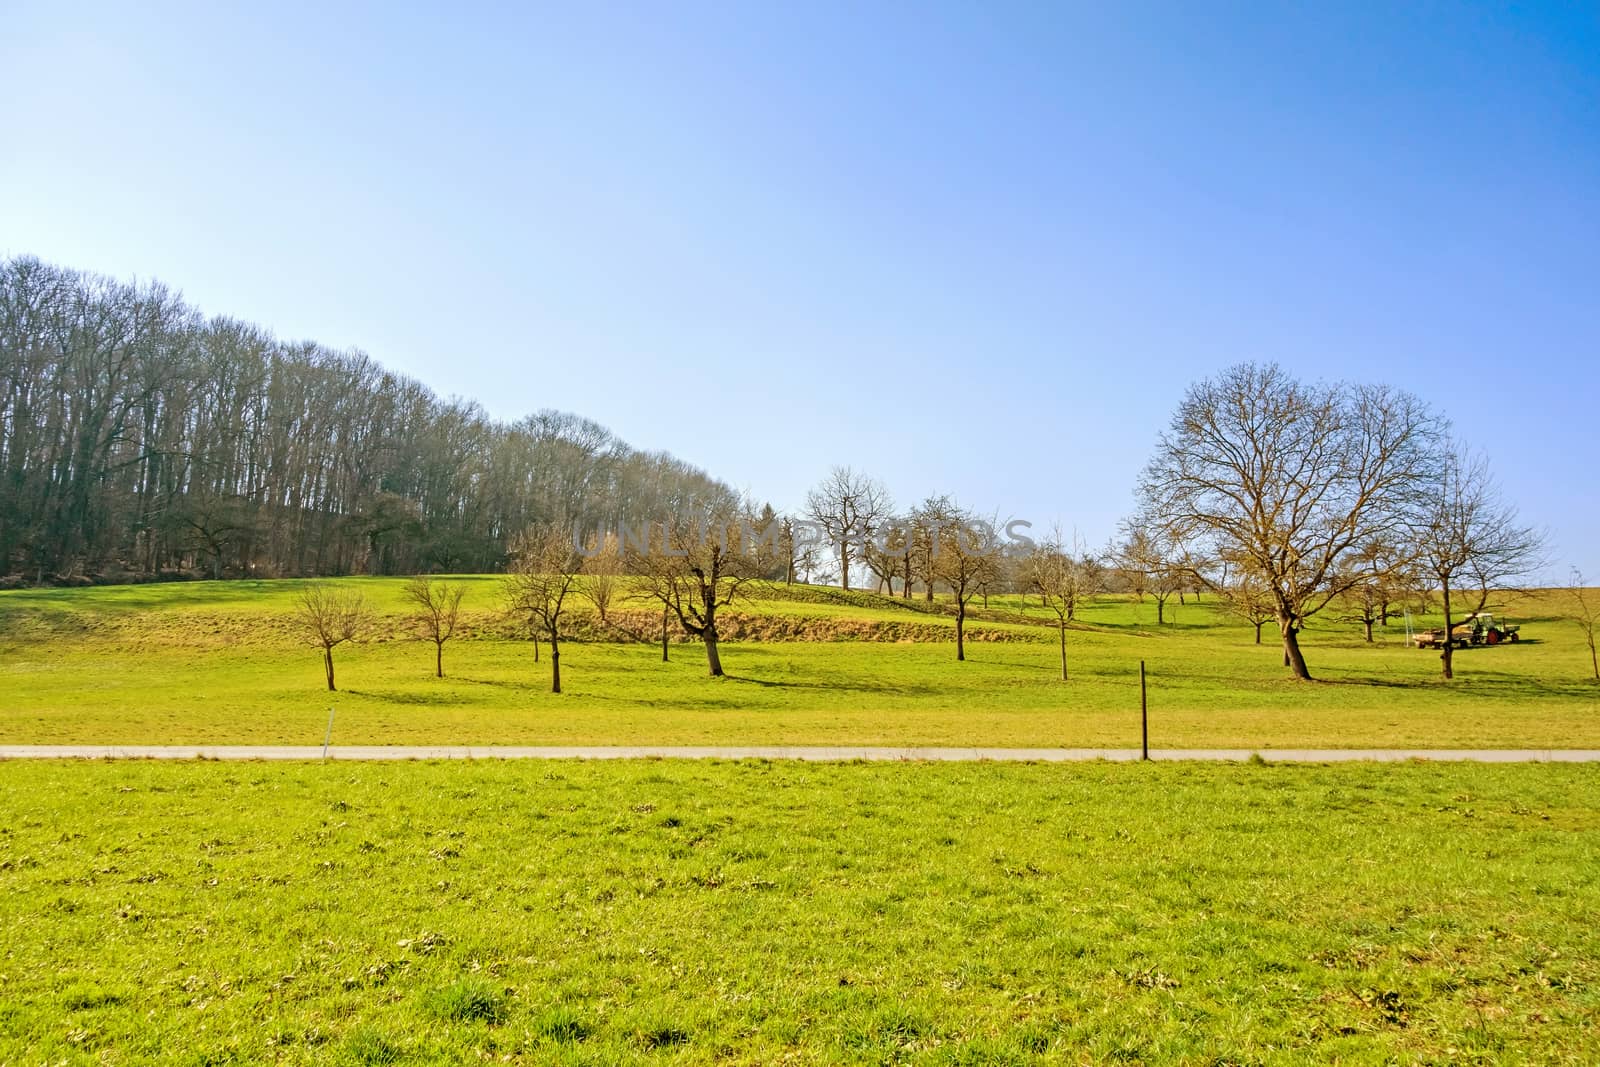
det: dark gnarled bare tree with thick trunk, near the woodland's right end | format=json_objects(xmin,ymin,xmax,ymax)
[{"xmin": 629, "ymin": 507, "xmax": 760, "ymax": 678}]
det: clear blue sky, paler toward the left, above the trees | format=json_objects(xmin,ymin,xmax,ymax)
[{"xmin": 0, "ymin": 0, "xmax": 1600, "ymax": 579}]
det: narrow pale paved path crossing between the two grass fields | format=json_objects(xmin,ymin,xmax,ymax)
[{"xmin": 0, "ymin": 745, "xmax": 1600, "ymax": 763}]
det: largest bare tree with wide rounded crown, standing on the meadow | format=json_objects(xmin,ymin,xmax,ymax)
[{"xmin": 1139, "ymin": 363, "xmax": 1442, "ymax": 678}]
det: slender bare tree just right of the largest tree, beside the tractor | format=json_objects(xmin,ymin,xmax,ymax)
[{"xmin": 1411, "ymin": 448, "xmax": 1544, "ymax": 680}]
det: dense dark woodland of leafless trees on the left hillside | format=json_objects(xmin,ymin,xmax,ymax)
[{"xmin": 0, "ymin": 258, "xmax": 733, "ymax": 582}]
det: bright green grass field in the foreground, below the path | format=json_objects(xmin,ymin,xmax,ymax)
[{"xmin": 0, "ymin": 761, "xmax": 1600, "ymax": 1064}]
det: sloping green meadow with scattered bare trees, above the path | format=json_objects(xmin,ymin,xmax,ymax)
[{"xmin": 0, "ymin": 576, "xmax": 1600, "ymax": 749}]
